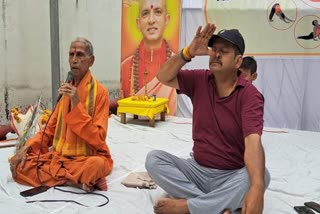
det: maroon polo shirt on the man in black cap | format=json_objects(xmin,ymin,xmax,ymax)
[{"xmin": 178, "ymin": 70, "xmax": 263, "ymax": 170}]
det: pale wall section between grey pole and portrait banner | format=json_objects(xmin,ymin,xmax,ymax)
[{"xmin": 59, "ymin": 0, "xmax": 122, "ymax": 98}]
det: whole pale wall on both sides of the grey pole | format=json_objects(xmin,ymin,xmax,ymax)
[{"xmin": 0, "ymin": 0, "xmax": 121, "ymax": 124}]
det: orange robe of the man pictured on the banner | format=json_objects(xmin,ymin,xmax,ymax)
[{"xmin": 121, "ymin": 41, "xmax": 177, "ymax": 115}]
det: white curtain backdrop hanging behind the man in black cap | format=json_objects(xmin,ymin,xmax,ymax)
[{"xmin": 177, "ymin": 0, "xmax": 320, "ymax": 131}]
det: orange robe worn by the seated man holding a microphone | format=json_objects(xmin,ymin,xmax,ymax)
[{"xmin": 14, "ymin": 71, "xmax": 113, "ymax": 190}]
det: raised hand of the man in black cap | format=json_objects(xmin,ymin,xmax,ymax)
[{"xmin": 189, "ymin": 23, "xmax": 216, "ymax": 56}]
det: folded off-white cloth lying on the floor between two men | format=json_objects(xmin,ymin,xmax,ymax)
[{"xmin": 121, "ymin": 172, "xmax": 157, "ymax": 189}]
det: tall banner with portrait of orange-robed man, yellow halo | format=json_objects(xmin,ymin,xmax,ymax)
[{"xmin": 120, "ymin": 0, "xmax": 181, "ymax": 115}]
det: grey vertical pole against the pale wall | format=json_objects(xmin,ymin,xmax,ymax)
[{"xmin": 50, "ymin": 0, "xmax": 60, "ymax": 106}]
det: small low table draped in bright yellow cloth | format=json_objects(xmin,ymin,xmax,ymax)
[{"xmin": 117, "ymin": 97, "xmax": 169, "ymax": 127}]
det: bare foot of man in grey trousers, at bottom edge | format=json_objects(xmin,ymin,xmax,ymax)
[{"xmin": 153, "ymin": 198, "xmax": 190, "ymax": 214}]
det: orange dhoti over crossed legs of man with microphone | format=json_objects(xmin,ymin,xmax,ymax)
[{"xmin": 14, "ymin": 152, "xmax": 112, "ymax": 190}]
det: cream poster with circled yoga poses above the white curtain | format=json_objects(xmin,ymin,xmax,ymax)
[{"xmin": 205, "ymin": 0, "xmax": 320, "ymax": 56}]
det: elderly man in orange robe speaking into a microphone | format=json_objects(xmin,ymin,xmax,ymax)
[{"xmin": 10, "ymin": 38, "xmax": 113, "ymax": 192}]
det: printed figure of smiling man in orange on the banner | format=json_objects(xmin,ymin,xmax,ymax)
[{"xmin": 121, "ymin": 0, "xmax": 177, "ymax": 115}]
